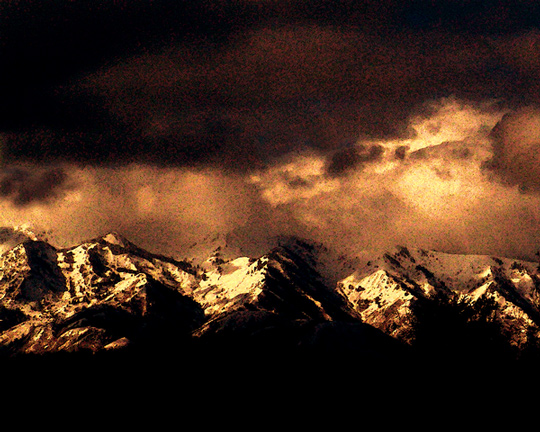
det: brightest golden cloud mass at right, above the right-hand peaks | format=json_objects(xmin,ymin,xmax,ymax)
[{"xmin": 253, "ymin": 100, "xmax": 540, "ymax": 259}]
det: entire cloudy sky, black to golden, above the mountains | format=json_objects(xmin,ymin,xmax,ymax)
[{"xmin": 0, "ymin": 0, "xmax": 540, "ymax": 259}]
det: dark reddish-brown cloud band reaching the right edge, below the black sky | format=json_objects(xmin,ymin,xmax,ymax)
[{"xmin": 3, "ymin": 22, "xmax": 540, "ymax": 171}]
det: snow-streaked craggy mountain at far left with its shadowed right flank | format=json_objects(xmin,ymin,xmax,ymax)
[{"xmin": 0, "ymin": 236, "xmax": 203, "ymax": 353}]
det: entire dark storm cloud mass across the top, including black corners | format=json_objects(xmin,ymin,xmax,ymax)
[{"xmin": 0, "ymin": 0, "xmax": 540, "ymax": 171}]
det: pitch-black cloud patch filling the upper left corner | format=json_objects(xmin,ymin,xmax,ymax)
[{"xmin": 0, "ymin": 0, "xmax": 253, "ymax": 126}]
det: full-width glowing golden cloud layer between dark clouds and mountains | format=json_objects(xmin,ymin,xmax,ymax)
[{"xmin": 0, "ymin": 99, "xmax": 540, "ymax": 259}]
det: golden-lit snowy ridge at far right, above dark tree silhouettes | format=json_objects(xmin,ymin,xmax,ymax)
[{"xmin": 338, "ymin": 247, "xmax": 540, "ymax": 344}]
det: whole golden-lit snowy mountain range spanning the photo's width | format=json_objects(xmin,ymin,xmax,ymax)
[{"xmin": 0, "ymin": 233, "xmax": 540, "ymax": 361}]
